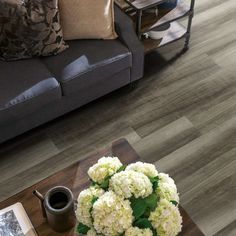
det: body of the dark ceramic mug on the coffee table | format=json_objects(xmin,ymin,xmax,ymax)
[{"xmin": 43, "ymin": 186, "xmax": 75, "ymax": 232}]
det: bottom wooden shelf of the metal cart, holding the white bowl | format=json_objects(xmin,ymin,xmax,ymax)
[{"xmin": 142, "ymin": 22, "xmax": 187, "ymax": 53}]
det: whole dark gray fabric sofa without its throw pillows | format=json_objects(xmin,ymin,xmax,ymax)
[{"xmin": 0, "ymin": 7, "xmax": 144, "ymax": 143}]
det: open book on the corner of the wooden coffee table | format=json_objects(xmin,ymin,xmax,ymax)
[{"xmin": 0, "ymin": 203, "xmax": 37, "ymax": 236}]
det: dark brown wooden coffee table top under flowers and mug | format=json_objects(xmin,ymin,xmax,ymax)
[{"xmin": 0, "ymin": 139, "xmax": 204, "ymax": 236}]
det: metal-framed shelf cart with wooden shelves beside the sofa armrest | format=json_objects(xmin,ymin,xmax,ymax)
[{"xmin": 121, "ymin": 0, "xmax": 195, "ymax": 53}]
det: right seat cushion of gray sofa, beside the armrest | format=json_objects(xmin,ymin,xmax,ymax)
[{"xmin": 42, "ymin": 40, "xmax": 132, "ymax": 95}]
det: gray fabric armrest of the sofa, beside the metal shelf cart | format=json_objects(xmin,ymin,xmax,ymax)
[{"xmin": 115, "ymin": 5, "xmax": 144, "ymax": 81}]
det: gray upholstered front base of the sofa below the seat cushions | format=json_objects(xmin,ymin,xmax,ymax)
[{"xmin": 0, "ymin": 69, "xmax": 130, "ymax": 143}]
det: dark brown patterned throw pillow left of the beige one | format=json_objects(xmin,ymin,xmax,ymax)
[{"xmin": 0, "ymin": 0, "xmax": 68, "ymax": 61}]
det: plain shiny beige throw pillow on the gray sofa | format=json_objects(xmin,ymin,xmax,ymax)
[{"xmin": 59, "ymin": 0, "xmax": 117, "ymax": 40}]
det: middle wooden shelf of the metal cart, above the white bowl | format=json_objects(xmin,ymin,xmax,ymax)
[{"xmin": 141, "ymin": 2, "xmax": 191, "ymax": 33}]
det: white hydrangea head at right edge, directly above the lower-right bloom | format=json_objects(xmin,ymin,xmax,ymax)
[{"xmin": 156, "ymin": 173, "xmax": 179, "ymax": 203}]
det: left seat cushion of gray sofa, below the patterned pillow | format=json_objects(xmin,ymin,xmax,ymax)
[{"xmin": 0, "ymin": 59, "xmax": 61, "ymax": 123}]
